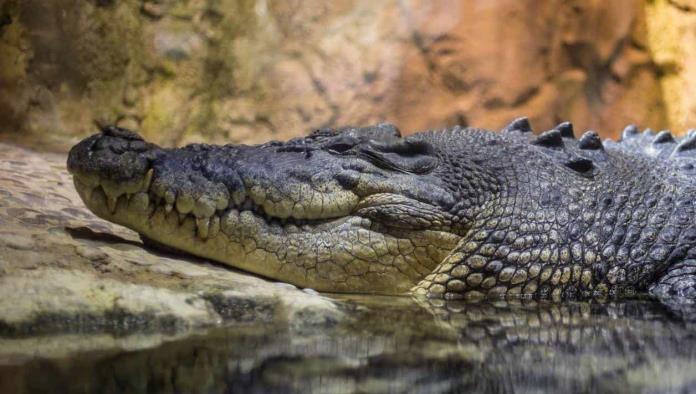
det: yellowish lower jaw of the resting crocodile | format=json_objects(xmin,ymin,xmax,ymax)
[{"xmin": 74, "ymin": 176, "xmax": 460, "ymax": 294}]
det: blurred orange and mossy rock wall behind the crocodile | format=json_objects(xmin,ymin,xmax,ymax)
[{"xmin": 0, "ymin": 0, "xmax": 696, "ymax": 150}]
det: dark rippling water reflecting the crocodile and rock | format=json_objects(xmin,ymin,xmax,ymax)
[{"xmin": 0, "ymin": 297, "xmax": 696, "ymax": 393}]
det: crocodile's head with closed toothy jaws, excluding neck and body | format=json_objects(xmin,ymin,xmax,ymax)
[{"xmin": 68, "ymin": 124, "xmax": 498, "ymax": 293}]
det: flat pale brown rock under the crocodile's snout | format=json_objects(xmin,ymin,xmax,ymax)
[{"xmin": 0, "ymin": 144, "xmax": 342, "ymax": 354}]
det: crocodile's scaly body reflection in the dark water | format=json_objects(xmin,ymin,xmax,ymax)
[{"xmin": 419, "ymin": 300, "xmax": 696, "ymax": 392}]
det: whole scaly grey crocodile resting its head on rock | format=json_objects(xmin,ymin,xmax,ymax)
[{"xmin": 67, "ymin": 118, "xmax": 696, "ymax": 302}]
